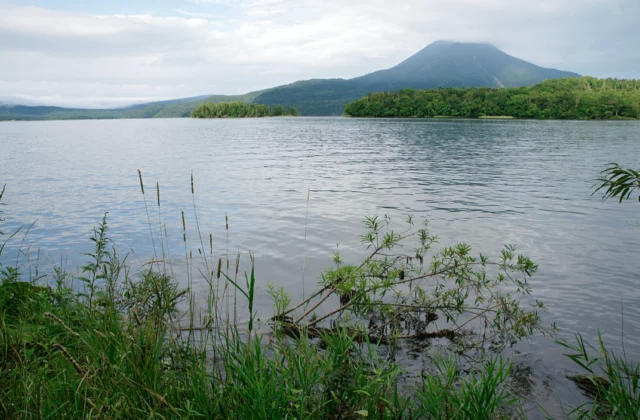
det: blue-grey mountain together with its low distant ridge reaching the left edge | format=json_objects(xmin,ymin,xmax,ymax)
[{"xmin": 0, "ymin": 41, "xmax": 580, "ymax": 120}]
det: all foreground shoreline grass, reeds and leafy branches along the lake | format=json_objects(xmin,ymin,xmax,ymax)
[{"xmin": 0, "ymin": 171, "xmax": 640, "ymax": 420}]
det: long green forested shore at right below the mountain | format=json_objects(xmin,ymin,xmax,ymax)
[{"xmin": 344, "ymin": 77, "xmax": 640, "ymax": 119}]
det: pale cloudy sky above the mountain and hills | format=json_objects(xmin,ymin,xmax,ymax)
[{"xmin": 0, "ymin": 0, "xmax": 640, "ymax": 108}]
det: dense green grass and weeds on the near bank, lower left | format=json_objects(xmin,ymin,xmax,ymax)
[{"xmin": 0, "ymin": 215, "xmax": 528, "ymax": 419}]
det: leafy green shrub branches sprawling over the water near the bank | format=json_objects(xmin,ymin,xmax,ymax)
[{"xmin": 276, "ymin": 217, "xmax": 543, "ymax": 353}]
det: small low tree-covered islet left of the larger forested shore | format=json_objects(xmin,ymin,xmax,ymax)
[{"xmin": 191, "ymin": 102, "xmax": 300, "ymax": 118}]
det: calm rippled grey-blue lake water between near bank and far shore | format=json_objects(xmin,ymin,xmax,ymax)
[{"xmin": 0, "ymin": 118, "xmax": 640, "ymax": 415}]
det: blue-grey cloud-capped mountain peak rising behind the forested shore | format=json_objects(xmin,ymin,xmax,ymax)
[{"xmin": 256, "ymin": 41, "xmax": 580, "ymax": 115}]
